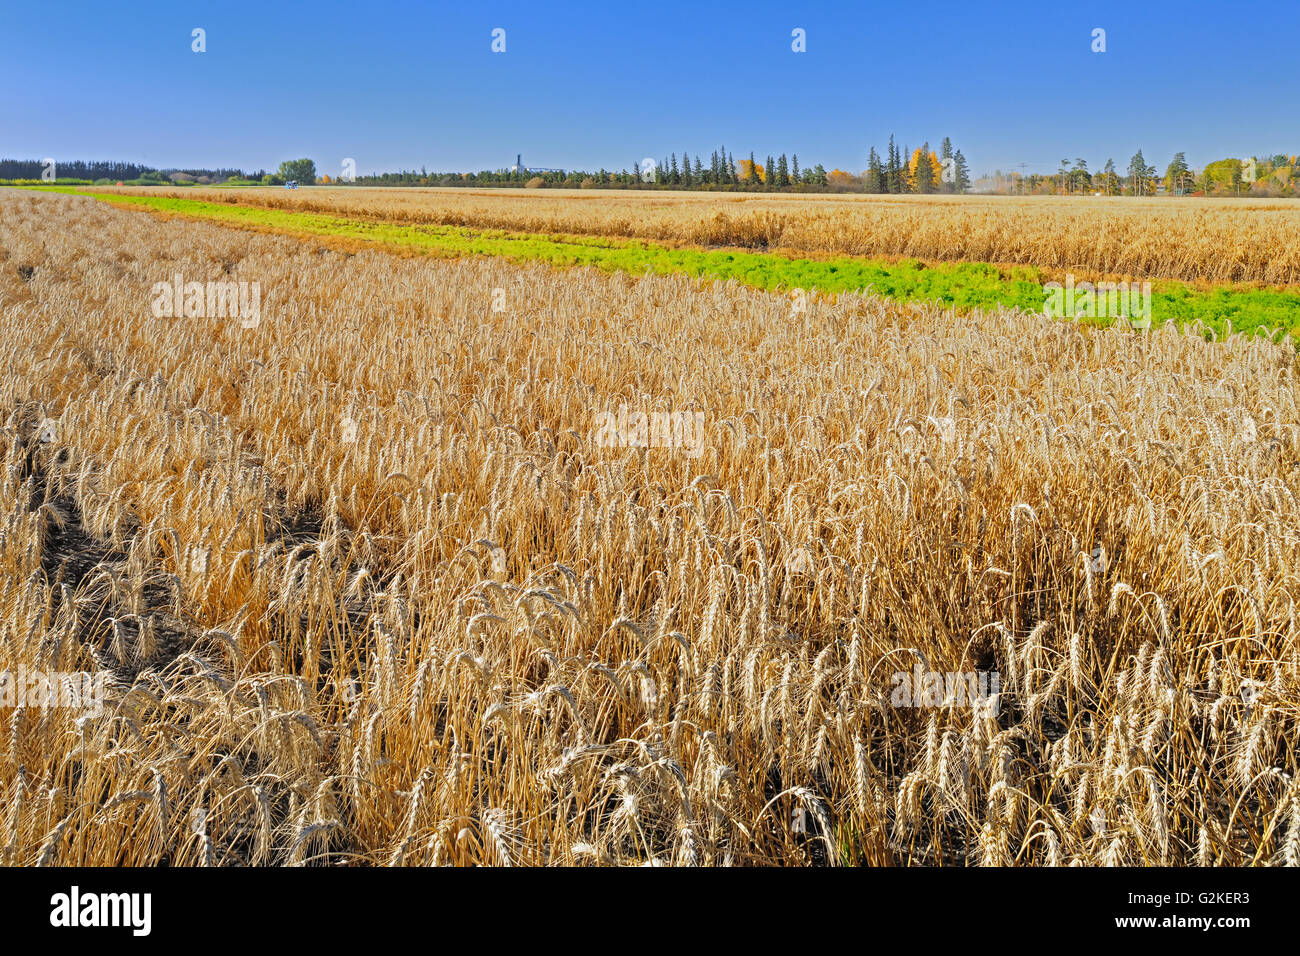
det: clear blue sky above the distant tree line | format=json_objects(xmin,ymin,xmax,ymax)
[{"xmin": 0, "ymin": 0, "xmax": 1300, "ymax": 176}]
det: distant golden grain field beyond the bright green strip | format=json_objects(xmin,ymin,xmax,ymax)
[{"xmin": 94, "ymin": 187, "xmax": 1300, "ymax": 285}]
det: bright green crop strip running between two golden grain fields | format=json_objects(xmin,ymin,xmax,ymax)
[{"xmin": 12, "ymin": 186, "xmax": 1300, "ymax": 337}]
